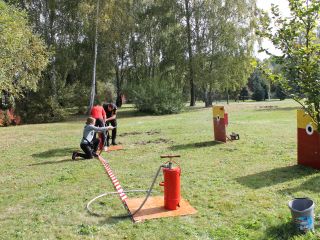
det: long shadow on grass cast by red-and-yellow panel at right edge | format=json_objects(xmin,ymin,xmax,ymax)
[{"xmin": 236, "ymin": 165, "xmax": 317, "ymax": 189}]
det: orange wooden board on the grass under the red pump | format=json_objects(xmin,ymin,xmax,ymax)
[{"xmin": 126, "ymin": 196, "xmax": 197, "ymax": 222}]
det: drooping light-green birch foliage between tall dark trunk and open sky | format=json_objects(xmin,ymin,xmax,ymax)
[{"xmin": 188, "ymin": 0, "xmax": 258, "ymax": 106}]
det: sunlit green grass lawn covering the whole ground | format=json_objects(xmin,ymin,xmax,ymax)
[{"xmin": 0, "ymin": 101, "xmax": 320, "ymax": 240}]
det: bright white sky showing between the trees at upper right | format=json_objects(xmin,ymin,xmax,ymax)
[{"xmin": 256, "ymin": 0, "xmax": 289, "ymax": 60}]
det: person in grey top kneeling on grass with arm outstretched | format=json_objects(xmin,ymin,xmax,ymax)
[{"xmin": 72, "ymin": 117, "xmax": 114, "ymax": 160}]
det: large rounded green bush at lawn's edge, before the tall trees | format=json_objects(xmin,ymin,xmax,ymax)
[{"xmin": 133, "ymin": 78, "xmax": 184, "ymax": 115}]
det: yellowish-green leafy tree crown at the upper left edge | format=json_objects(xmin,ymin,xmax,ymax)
[{"xmin": 0, "ymin": 0, "xmax": 49, "ymax": 99}]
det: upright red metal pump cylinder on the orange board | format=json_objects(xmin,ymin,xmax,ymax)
[{"xmin": 163, "ymin": 167, "xmax": 181, "ymax": 210}]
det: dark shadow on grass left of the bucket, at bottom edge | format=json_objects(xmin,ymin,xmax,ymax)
[{"xmin": 263, "ymin": 222, "xmax": 298, "ymax": 240}]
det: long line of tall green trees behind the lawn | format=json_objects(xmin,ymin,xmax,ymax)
[{"xmin": 0, "ymin": 0, "xmax": 260, "ymax": 122}]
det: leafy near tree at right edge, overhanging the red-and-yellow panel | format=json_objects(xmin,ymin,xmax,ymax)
[{"xmin": 258, "ymin": 0, "xmax": 320, "ymax": 132}]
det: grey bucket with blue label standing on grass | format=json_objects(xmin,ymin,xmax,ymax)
[{"xmin": 288, "ymin": 198, "xmax": 315, "ymax": 233}]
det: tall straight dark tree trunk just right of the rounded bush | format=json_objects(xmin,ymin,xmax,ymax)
[{"xmin": 184, "ymin": 0, "xmax": 196, "ymax": 106}]
